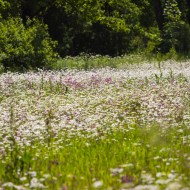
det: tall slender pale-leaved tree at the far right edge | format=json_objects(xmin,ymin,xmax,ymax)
[{"xmin": 162, "ymin": 0, "xmax": 190, "ymax": 55}]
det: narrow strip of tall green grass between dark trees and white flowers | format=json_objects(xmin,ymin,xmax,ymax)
[{"xmin": 52, "ymin": 52, "xmax": 188, "ymax": 70}]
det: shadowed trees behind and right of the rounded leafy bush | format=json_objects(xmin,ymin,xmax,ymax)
[{"xmin": 0, "ymin": 0, "xmax": 190, "ymax": 68}]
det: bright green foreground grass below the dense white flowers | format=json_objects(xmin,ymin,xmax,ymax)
[{"xmin": 0, "ymin": 124, "xmax": 190, "ymax": 189}]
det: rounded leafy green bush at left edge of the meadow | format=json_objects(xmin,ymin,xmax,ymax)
[{"xmin": 0, "ymin": 18, "xmax": 57, "ymax": 70}]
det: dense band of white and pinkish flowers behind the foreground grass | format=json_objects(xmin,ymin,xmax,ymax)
[{"xmin": 0, "ymin": 63, "xmax": 190, "ymax": 152}]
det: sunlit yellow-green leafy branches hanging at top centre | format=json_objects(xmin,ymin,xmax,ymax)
[{"xmin": 56, "ymin": 0, "xmax": 139, "ymax": 31}]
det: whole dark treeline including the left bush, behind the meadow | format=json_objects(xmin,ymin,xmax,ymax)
[{"xmin": 0, "ymin": 0, "xmax": 190, "ymax": 68}]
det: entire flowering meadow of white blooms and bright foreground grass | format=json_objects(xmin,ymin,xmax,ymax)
[{"xmin": 0, "ymin": 62, "xmax": 190, "ymax": 190}]
